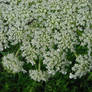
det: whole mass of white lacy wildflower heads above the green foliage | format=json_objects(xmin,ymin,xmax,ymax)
[{"xmin": 0, "ymin": 0, "xmax": 92, "ymax": 81}]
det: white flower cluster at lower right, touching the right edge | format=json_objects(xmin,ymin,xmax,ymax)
[{"xmin": 70, "ymin": 55, "xmax": 92, "ymax": 79}]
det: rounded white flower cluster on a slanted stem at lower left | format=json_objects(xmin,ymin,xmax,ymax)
[{"xmin": 2, "ymin": 53, "xmax": 24, "ymax": 73}]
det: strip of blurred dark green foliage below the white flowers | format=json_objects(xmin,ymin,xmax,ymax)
[{"xmin": 0, "ymin": 71, "xmax": 92, "ymax": 92}]
